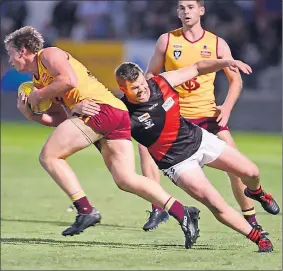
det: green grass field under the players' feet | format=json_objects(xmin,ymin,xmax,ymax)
[{"xmin": 1, "ymin": 123, "xmax": 282, "ymax": 270}]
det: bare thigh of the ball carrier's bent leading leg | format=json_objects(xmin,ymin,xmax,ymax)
[{"xmin": 40, "ymin": 119, "xmax": 101, "ymax": 159}]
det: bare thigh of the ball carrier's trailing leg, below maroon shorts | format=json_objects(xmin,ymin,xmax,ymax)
[{"xmin": 100, "ymin": 138, "xmax": 135, "ymax": 181}]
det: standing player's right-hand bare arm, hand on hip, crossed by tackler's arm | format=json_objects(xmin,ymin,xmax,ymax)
[{"xmin": 217, "ymin": 38, "xmax": 243, "ymax": 127}]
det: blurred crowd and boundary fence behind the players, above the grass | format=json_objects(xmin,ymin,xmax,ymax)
[{"xmin": 0, "ymin": 0, "xmax": 282, "ymax": 132}]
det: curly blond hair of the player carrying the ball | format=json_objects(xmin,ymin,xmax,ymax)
[{"xmin": 4, "ymin": 26, "xmax": 44, "ymax": 54}]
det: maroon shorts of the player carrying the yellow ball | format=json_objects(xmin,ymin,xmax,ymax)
[{"xmin": 74, "ymin": 104, "xmax": 131, "ymax": 140}]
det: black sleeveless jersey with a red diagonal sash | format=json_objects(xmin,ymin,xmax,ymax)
[{"xmin": 122, "ymin": 76, "xmax": 202, "ymax": 169}]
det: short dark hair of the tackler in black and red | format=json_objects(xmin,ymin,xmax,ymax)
[{"xmin": 115, "ymin": 62, "xmax": 143, "ymax": 82}]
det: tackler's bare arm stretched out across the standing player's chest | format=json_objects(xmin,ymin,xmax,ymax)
[{"xmin": 161, "ymin": 59, "xmax": 252, "ymax": 87}]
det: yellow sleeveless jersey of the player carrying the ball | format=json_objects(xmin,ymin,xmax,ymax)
[{"xmin": 33, "ymin": 50, "xmax": 127, "ymax": 110}]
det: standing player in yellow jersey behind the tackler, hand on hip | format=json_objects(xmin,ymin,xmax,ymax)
[{"xmin": 139, "ymin": 0, "xmax": 264, "ymax": 232}]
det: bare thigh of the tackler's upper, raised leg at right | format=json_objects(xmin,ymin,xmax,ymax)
[{"xmin": 207, "ymin": 145, "xmax": 259, "ymax": 180}]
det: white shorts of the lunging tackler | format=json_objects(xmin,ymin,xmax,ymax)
[{"xmin": 162, "ymin": 128, "xmax": 226, "ymax": 184}]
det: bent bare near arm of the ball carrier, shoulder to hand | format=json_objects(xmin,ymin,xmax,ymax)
[{"xmin": 28, "ymin": 47, "xmax": 78, "ymax": 106}]
